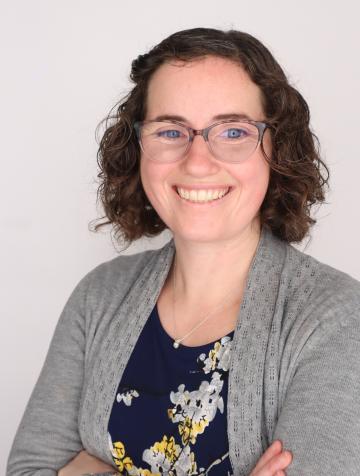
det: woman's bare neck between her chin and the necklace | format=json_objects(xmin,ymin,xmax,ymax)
[{"xmin": 169, "ymin": 220, "xmax": 260, "ymax": 308}]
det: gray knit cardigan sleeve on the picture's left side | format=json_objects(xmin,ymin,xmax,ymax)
[{"xmin": 6, "ymin": 274, "xmax": 95, "ymax": 476}]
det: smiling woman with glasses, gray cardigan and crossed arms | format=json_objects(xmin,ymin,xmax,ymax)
[{"xmin": 8, "ymin": 28, "xmax": 360, "ymax": 476}]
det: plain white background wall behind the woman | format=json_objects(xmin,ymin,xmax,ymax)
[{"xmin": 0, "ymin": 0, "xmax": 360, "ymax": 468}]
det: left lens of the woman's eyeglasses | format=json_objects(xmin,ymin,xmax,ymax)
[{"xmin": 140, "ymin": 121, "xmax": 189, "ymax": 162}]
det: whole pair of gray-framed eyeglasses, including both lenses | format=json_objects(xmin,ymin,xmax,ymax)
[{"xmin": 134, "ymin": 120, "xmax": 270, "ymax": 163}]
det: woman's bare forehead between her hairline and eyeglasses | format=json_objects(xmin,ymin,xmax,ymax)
[{"xmin": 146, "ymin": 56, "xmax": 264, "ymax": 127}]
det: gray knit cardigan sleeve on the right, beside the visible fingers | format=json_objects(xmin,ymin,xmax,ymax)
[{"xmin": 273, "ymin": 312, "xmax": 360, "ymax": 476}]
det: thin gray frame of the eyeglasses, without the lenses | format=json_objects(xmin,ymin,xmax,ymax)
[{"xmin": 133, "ymin": 119, "xmax": 271, "ymax": 164}]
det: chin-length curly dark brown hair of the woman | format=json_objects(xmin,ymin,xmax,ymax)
[{"xmin": 89, "ymin": 28, "xmax": 329, "ymax": 244}]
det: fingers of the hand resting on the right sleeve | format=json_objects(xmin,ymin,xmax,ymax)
[{"xmin": 250, "ymin": 440, "xmax": 293, "ymax": 476}]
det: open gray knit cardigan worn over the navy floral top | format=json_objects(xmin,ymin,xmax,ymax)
[{"xmin": 7, "ymin": 228, "xmax": 360, "ymax": 476}]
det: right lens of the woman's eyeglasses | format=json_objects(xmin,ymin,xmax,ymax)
[{"xmin": 209, "ymin": 122, "xmax": 259, "ymax": 162}]
